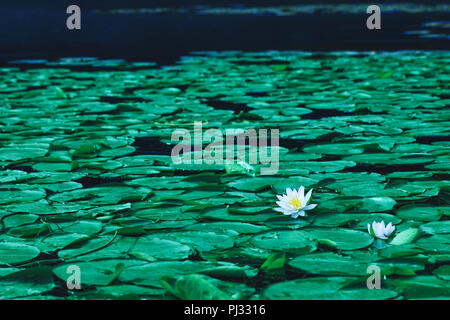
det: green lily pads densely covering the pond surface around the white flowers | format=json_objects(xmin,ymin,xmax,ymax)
[{"xmin": 0, "ymin": 52, "xmax": 450, "ymax": 299}]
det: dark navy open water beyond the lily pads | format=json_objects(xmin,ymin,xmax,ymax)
[{"xmin": 0, "ymin": 0, "xmax": 450, "ymax": 64}]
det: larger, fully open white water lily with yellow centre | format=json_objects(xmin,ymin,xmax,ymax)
[{"xmin": 275, "ymin": 186, "xmax": 317, "ymax": 219}]
